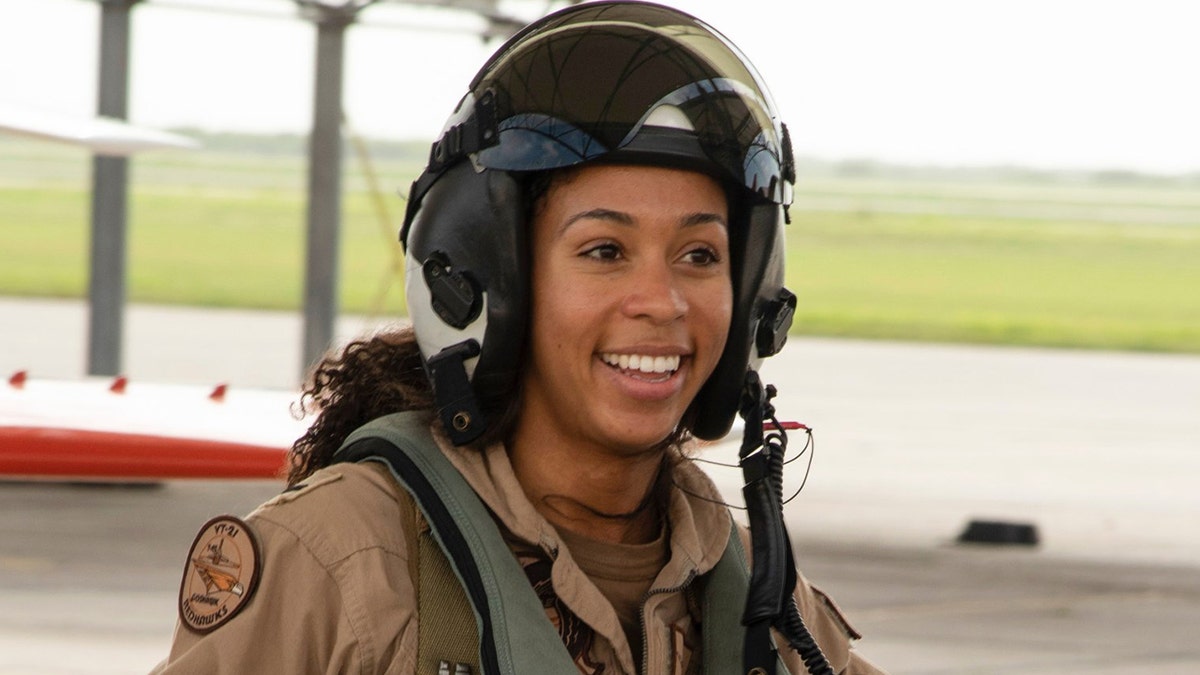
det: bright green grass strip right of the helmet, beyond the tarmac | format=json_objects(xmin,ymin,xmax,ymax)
[{"xmin": 788, "ymin": 213, "xmax": 1200, "ymax": 352}]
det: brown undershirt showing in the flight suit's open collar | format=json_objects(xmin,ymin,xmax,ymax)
[{"xmin": 559, "ymin": 528, "xmax": 668, "ymax": 670}]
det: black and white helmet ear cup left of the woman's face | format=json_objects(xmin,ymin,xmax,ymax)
[{"xmin": 403, "ymin": 162, "xmax": 529, "ymax": 437}]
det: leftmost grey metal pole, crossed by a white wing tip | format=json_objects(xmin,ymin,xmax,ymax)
[{"xmin": 88, "ymin": 0, "xmax": 138, "ymax": 375}]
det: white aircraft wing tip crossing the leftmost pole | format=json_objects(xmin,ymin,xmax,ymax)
[{"xmin": 0, "ymin": 103, "xmax": 199, "ymax": 156}]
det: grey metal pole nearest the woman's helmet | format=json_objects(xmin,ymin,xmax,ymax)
[{"xmin": 301, "ymin": 7, "xmax": 354, "ymax": 376}]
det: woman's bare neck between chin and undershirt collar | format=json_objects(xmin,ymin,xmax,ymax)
[{"xmin": 509, "ymin": 430, "xmax": 665, "ymax": 544}]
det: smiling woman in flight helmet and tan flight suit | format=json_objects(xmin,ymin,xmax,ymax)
[{"xmin": 152, "ymin": 2, "xmax": 878, "ymax": 674}]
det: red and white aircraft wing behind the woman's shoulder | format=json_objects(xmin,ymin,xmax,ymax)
[{"xmin": 0, "ymin": 372, "xmax": 306, "ymax": 483}]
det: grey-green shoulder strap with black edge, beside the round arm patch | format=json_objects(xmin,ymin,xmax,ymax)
[{"xmin": 336, "ymin": 412, "xmax": 577, "ymax": 675}]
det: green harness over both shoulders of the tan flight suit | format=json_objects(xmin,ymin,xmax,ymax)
[{"xmin": 336, "ymin": 412, "xmax": 787, "ymax": 675}]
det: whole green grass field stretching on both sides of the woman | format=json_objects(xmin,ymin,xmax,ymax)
[{"xmin": 7, "ymin": 132, "xmax": 1200, "ymax": 352}]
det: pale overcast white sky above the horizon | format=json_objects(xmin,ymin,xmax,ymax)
[{"xmin": 0, "ymin": 0, "xmax": 1200, "ymax": 172}]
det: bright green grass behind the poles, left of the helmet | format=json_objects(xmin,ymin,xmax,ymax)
[{"xmin": 0, "ymin": 187, "xmax": 412, "ymax": 312}]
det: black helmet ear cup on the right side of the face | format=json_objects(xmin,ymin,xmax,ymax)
[{"xmin": 691, "ymin": 204, "xmax": 791, "ymax": 441}]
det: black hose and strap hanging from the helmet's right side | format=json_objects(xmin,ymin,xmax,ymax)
[{"xmin": 738, "ymin": 370, "xmax": 833, "ymax": 675}]
